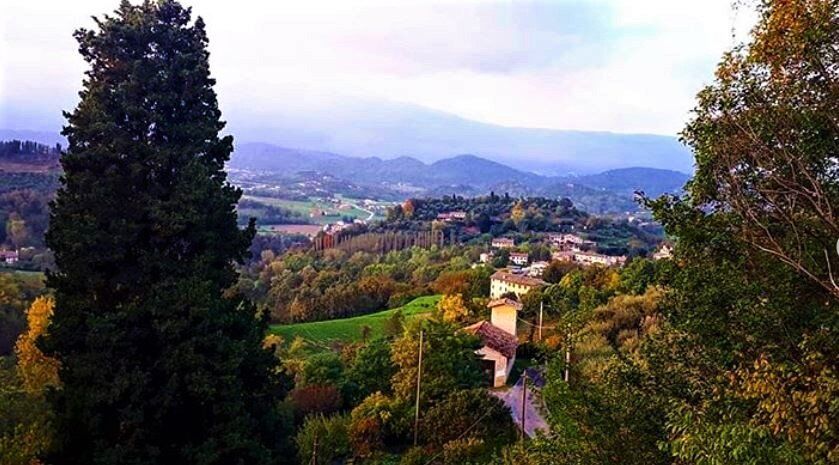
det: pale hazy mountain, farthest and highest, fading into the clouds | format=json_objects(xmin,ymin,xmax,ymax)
[{"xmin": 220, "ymin": 99, "xmax": 693, "ymax": 175}]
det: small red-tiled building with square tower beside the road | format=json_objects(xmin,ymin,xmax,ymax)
[{"xmin": 464, "ymin": 299, "xmax": 521, "ymax": 387}]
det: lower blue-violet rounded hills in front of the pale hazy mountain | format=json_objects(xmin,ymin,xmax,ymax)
[{"xmin": 230, "ymin": 143, "xmax": 689, "ymax": 212}]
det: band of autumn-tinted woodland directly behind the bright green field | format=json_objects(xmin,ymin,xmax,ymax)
[{"xmin": 239, "ymin": 246, "xmax": 490, "ymax": 322}]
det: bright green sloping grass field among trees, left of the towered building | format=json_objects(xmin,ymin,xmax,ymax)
[{"xmin": 270, "ymin": 295, "xmax": 440, "ymax": 344}]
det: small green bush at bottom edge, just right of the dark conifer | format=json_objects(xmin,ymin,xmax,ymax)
[{"xmin": 295, "ymin": 415, "xmax": 350, "ymax": 463}]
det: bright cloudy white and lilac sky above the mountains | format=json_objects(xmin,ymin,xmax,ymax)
[{"xmin": 0, "ymin": 0, "xmax": 751, "ymax": 135}]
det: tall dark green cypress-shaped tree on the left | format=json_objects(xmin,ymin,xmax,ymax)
[{"xmin": 43, "ymin": 0, "xmax": 292, "ymax": 464}]
